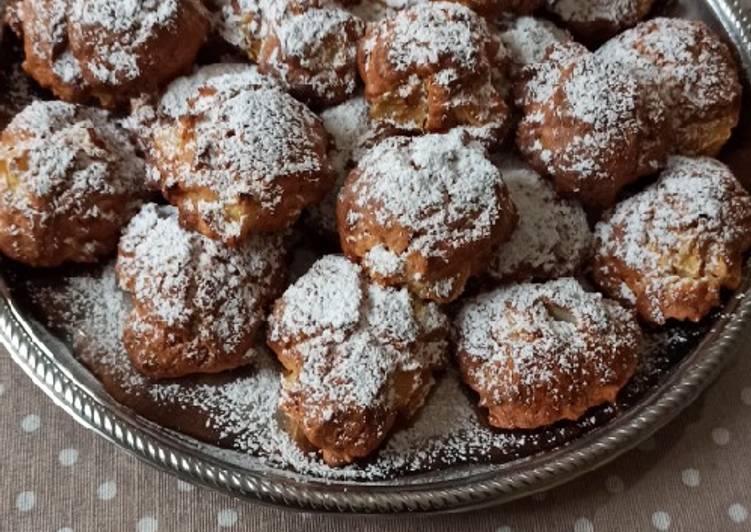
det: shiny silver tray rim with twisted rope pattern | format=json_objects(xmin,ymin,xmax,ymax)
[{"xmin": 0, "ymin": 0, "xmax": 751, "ymax": 514}]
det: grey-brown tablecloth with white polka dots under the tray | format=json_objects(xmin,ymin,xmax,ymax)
[{"xmin": 0, "ymin": 331, "xmax": 751, "ymax": 532}]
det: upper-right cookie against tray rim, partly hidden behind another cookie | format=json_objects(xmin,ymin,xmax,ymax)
[{"xmin": 597, "ymin": 18, "xmax": 742, "ymax": 156}]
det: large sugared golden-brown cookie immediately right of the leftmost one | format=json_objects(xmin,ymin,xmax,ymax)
[{"xmin": 150, "ymin": 88, "xmax": 334, "ymax": 245}]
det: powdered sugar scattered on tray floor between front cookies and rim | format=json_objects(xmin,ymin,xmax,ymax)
[{"xmin": 11, "ymin": 264, "xmax": 708, "ymax": 481}]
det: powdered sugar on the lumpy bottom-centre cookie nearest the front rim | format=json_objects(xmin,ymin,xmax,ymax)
[{"xmin": 269, "ymin": 255, "xmax": 448, "ymax": 417}]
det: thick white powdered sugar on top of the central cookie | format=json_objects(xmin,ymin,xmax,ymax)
[{"xmin": 346, "ymin": 133, "xmax": 507, "ymax": 264}]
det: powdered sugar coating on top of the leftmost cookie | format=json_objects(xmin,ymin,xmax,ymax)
[{"xmin": 0, "ymin": 101, "xmax": 144, "ymax": 226}]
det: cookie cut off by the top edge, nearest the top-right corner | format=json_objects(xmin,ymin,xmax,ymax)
[{"xmin": 545, "ymin": 0, "xmax": 655, "ymax": 46}]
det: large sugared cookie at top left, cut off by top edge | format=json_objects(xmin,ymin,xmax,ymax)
[{"xmin": 16, "ymin": 0, "xmax": 210, "ymax": 107}]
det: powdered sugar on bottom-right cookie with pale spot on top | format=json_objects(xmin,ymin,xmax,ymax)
[{"xmin": 456, "ymin": 278, "xmax": 641, "ymax": 404}]
